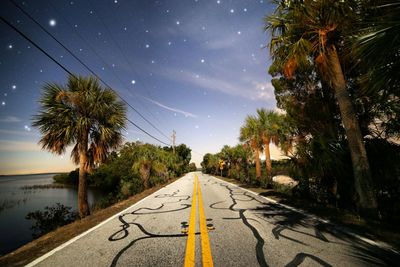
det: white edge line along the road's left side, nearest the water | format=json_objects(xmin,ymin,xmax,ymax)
[{"xmin": 25, "ymin": 174, "xmax": 187, "ymax": 267}]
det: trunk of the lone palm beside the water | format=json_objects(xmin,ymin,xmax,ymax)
[{"xmin": 78, "ymin": 135, "xmax": 90, "ymax": 219}]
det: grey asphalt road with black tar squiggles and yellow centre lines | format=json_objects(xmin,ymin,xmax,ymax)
[{"xmin": 28, "ymin": 172, "xmax": 400, "ymax": 267}]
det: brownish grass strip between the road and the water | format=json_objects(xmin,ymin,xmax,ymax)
[{"xmin": 0, "ymin": 177, "xmax": 181, "ymax": 266}]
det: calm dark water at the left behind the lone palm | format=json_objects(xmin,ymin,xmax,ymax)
[{"xmin": 0, "ymin": 174, "xmax": 102, "ymax": 255}]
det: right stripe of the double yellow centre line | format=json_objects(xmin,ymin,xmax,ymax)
[{"xmin": 195, "ymin": 175, "xmax": 214, "ymax": 267}]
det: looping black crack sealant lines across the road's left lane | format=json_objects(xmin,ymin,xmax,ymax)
[{"xmin": 108, "ymin": 190, "xmax": 192, "ymax": 267}]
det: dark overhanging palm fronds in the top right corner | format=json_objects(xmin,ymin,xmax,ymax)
[{"xmin": 354, "ymin": 0, "xmax": 400, "ymax": 93}]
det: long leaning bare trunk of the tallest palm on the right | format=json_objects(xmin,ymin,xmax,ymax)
[{"xmin": 327, "ymin": 46, "xmax": 378, "ymax": 217}]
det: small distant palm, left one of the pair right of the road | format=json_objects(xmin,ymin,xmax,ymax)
[{"xmin": 239, "ymin": 115, "xmax": 261, "ymax": 181}]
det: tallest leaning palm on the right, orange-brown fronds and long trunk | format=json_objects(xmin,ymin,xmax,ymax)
[{"xmin": 266, "ymin": 0, "xmax": 377, "ymax": 216}]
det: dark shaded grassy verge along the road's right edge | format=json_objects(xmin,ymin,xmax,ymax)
[{"xmin": 215, "ymin": 176, "xmax": 400, "ymax": 251}]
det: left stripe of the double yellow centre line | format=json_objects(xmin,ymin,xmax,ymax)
[{"xmin": 184, "ymin": 176, "xmax": 198, "ymax": 267}]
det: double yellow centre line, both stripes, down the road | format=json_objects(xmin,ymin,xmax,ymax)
[{"xmin": 184, "ymin": 175, "xmax": 214, "ymax": 267}]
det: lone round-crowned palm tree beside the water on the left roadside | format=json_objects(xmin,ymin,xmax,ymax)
[{"xmin": 33, "ymin": 75, "xmax": 126, "ymax": 218}]
